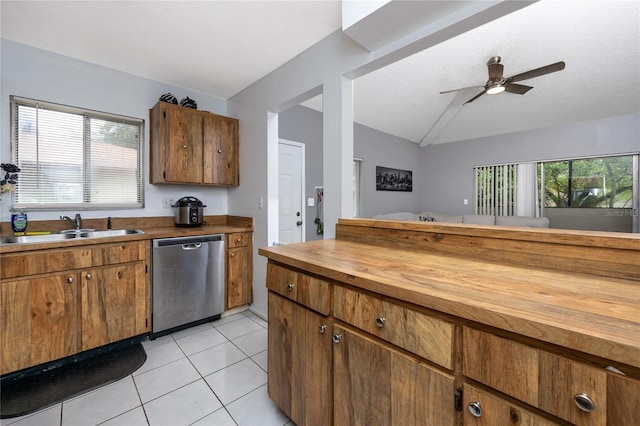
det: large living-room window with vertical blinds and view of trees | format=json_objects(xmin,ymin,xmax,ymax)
[{"xmin": 474, "ymin": 154, "xmax": 640, "ymax": 232}]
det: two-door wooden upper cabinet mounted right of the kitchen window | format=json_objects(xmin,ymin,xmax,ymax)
[{"xmin": 150, "ymin": 102, "xmax": 239, "ymax": 186}]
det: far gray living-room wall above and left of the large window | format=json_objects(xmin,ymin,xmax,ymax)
[{"xmin": 422, "ymin": 113, "xmax": 640, "ymax": 214}]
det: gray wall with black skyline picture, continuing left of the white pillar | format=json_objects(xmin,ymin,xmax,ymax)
[{"xmin": 278, "ymin": 107, "xmax": 422, "ymax": 225}]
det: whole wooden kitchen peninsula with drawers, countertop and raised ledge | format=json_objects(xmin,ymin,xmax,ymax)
[{"xmin": 259, "ymin": 219, "xmax": 640, "ymax": 426}]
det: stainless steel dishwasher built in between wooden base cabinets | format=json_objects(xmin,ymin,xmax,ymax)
[{"xmin": 151, "ymin": 234, "xmax": 225, "ymax": 338}]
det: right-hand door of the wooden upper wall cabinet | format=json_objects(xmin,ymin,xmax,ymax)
[{"xmin": 203, "ymin": 115, "xmax": 239, "ymax": 186}]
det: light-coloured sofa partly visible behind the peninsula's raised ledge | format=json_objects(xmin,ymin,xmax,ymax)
[{"xmin": 373, "ymin": 212, "xmax": 549, "ymax": 228}]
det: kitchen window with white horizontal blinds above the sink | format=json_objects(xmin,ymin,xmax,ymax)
[{"xmin": 11, "ymin": 96, "xmax": 144, "ymax": 210}]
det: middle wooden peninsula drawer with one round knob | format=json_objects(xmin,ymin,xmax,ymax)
[{"xmin": 333, "ymin": 286, "xmax": 454, "ymax": 370}]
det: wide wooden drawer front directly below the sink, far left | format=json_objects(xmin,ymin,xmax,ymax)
[{"xmin": 1, "ymin": 247, "xmax": 92, "ymax": 279}]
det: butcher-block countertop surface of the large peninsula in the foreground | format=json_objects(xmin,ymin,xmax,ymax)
[{"xmin": 259, "ymin": 238, "xmax": 640, "ymax": 368}]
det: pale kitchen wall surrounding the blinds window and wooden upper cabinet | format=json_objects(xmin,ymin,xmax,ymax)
[{"xmin": 0, "ymin": 39, "xmax": 230, "ymax": 222}]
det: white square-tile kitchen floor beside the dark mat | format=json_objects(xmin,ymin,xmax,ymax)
[{"xmin": 0, "ymin": 311, "xmax": 293, "ymax": 426}]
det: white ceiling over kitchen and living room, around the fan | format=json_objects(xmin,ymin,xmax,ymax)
[{"xmin": 0, "ymin": 0, "xmax": 640, "ymax": 144}]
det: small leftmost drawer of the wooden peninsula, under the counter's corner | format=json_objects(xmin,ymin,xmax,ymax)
[{"xmin": 267, "ymin": 262, "xmax": 331, "ymax": 315}]
